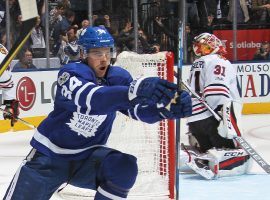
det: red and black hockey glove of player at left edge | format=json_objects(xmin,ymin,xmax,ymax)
[{"xmin": 3, "ymin": 99, "xmax": 20, "ymax": 127}]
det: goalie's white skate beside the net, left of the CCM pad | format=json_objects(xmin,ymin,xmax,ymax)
[{"xmin": 186, "ymin": 158, "xmax": 215, "ymax": 180}]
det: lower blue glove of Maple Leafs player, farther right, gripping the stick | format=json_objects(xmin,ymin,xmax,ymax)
[{"xmin": 158, "ymin": 91, "xmax": 192, "ymax": 119}]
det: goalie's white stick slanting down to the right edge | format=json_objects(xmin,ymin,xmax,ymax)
[{"xmin": 182, "ymin": 81, "xmax": 270, "ymax": 174}]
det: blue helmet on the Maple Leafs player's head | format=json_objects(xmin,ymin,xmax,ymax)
[{"xmin": 78, "ymin": 27, "xmax": 114, "ymax": 58}]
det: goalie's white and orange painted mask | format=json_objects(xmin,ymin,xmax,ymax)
[{"xmin": 193, "ymin": 33, "xmax": 227, "ymax": 57}]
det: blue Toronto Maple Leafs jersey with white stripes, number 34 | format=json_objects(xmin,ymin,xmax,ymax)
[{"xmin": 31, "ymin": 63, "xmax": 161, "ymax": 160}]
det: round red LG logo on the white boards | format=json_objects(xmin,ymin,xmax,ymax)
[{"xmin": 16, "ymin": 76, "xmax": 36, "ymax": 111}]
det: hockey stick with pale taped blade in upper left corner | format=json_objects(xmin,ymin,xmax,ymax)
[{"xmin": 0, "ymin": 0, "xmax": 38, "ymax": 76}]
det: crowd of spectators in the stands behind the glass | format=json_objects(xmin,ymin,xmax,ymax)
[{"xmin": 0, "ymin": 0, "xmax": 270, "ymax": 69}]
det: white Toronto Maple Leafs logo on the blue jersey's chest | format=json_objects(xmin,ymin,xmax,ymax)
[{"xmin": 67, "ymin": 112, "xmax": 107, "ymax": 138}]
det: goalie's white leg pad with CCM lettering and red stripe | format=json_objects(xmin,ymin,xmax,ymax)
[{"xmin": 208, "ymin": 149, "xmax": 250, "ymax": 177}]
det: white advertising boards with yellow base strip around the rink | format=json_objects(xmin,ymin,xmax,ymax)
[{"xmin": 0, "ymin": 62, "xmax": 270, "ymax": 132}]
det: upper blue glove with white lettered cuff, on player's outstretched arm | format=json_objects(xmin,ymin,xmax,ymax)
[{"xmin": 128, "ymin": 77, "xmax": 177, "ymax": 107}]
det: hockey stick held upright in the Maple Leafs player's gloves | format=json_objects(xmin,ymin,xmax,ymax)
[{"xmin": 175, "ymin": 21, "xmax": 184, "ymax": 200}]
